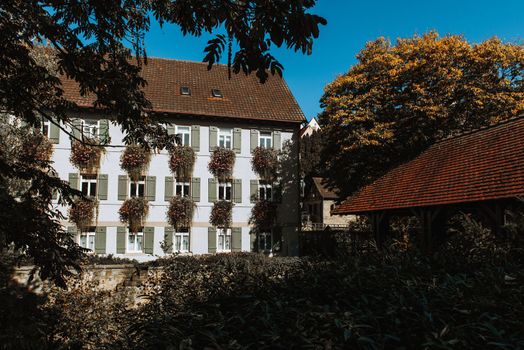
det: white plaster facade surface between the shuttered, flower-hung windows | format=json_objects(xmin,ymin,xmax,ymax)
[{"xmin": 52, "ymin": 114, "xmax": 299, "ymax": 261}]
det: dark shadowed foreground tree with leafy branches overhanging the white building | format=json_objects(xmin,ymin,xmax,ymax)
[{"xmin": 0, "ymin": 0, "xmax": 326, "ymax": 284}]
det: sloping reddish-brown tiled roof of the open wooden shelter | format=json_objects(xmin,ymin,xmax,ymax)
[{"xmin": 335, "ymin": 116, "xmax": 524, "ymax": 214}]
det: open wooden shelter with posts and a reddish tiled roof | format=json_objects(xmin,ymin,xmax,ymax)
[{"xmin": 334, "ymin": 116, "xmax": 524, "ymax": 252}]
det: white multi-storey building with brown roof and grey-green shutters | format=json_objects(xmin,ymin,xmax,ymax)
[{"xmin": 47, "ymin": 59, "xmax": 304, "ymax": 260}]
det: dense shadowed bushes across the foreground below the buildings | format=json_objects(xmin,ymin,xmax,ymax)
[{"xmin": 1, "ymin": 215, "xmax": 524, "ymax": 349}]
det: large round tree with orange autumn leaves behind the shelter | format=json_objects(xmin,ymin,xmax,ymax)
[{"xmin": 320, "ymin": 32, "xmax": 524, "ymax": 198}]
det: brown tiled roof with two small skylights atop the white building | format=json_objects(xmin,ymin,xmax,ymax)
[{"xmin": 62, "ymin": 58, "xmax": 305, "ymax": 122}]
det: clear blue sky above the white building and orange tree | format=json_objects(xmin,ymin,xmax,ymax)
[{"xmin": 146, "ymin": 0, "xmax": 524, "ymax": 119}]
